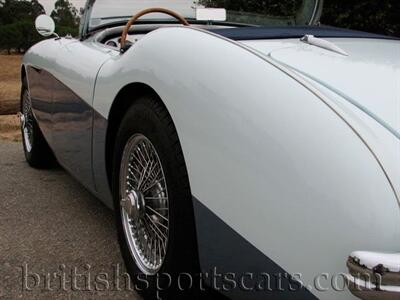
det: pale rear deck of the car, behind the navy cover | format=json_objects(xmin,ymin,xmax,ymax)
[{"xmin": 244, "ymin": 38, "xmax": 400, "ymax": 139}]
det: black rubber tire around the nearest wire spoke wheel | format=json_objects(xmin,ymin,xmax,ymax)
[{"xmin": 112, "ymin": 96, "xmax": 199, "ymax": 299}]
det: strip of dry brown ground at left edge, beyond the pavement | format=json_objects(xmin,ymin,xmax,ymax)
[{"xmin": 0, "ymin": 54, "xmax": 22, "ymax": 141}]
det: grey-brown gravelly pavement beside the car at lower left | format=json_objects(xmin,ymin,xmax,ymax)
[{"xmin": 0, "ymin": 140, "xmax": 137, "ymax": 299}]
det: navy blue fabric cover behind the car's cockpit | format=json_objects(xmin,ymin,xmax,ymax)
[{"xmin": 209, "ymin": 26, "xmax": 398, "ymax": 41}]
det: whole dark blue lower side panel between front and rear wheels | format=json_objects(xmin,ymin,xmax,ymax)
[{"xmin": 28, "ymin": 67, "xmax": 112, "ymax": 203}]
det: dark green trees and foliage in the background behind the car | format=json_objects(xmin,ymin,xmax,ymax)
[{"xmin": 0, "ymin": 0, "xmax": 400, "ymax": 52}]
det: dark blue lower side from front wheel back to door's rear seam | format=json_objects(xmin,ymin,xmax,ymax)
[{"xmin": 28, "ymin": 67, "xmax": 95, "ymax": 192}]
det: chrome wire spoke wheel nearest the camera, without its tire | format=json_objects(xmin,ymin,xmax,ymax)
[{"xmin": 119, "ymin": 134, "xmax": 170, "ymax": 275}]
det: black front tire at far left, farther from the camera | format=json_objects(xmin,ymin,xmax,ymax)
[{"xmin": 21, "ymin": 80, "xmax": 57, "ymax": 169}]
